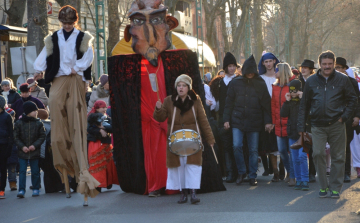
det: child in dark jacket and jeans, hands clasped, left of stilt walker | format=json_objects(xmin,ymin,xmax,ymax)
[{"xmin": 14, "ymin": 101, "xmax": 46, "ymax": 198}]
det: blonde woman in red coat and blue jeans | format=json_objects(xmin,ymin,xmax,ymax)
[{"xmin": 271, "ymin": 63, "xmax": 296, "ymax": 186}]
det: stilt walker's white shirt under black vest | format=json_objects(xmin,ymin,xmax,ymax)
[{"xmin": 34, "ymin": 28, "xmax": 94, "ymax": 81}]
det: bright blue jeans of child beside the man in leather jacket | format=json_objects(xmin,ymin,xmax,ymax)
[{"xmin": 289, "ymin": 139, "xmax": 309, "ymax": 182}]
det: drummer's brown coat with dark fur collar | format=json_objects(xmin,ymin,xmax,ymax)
[{"xmin": 154, "ymin": 91, "xmax": 215, "ymax": 168}]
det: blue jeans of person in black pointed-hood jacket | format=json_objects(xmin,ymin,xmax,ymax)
[{"xmin": 232, "ymin": 128, "xmax": 259, "ymax": 179}]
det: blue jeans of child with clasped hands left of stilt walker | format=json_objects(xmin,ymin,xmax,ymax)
[{"xmin": 19, "ymin": 159, "xmax": 40, "ymax": 191}]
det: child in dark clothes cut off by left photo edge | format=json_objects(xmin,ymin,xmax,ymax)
[{"xmin": 0, "ymin": 95, "xmax": 14, "ymax": 199}]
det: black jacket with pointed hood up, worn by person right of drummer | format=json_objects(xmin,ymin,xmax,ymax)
[{"xmin": 224, "ymin": 74, "xmax": 272, "ymax": 132}]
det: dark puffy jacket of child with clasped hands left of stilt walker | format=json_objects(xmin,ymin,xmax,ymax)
[{"xmin": 14, "ymin": 114, "xmax": 46, "ymax": 159}]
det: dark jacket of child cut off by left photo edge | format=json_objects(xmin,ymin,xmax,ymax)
[{"xmin": 0, "ymin": 110, "xmax": 14, "ymax": 157}]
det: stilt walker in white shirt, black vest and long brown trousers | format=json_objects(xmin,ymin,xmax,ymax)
[{"xmin": 34, "ymin": 5, "xmax": 99, "ymax": 206}]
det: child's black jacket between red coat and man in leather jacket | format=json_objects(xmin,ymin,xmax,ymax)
[{"xmin": 280, "ymin": 99, "xmax": 300, "ymax": 140}]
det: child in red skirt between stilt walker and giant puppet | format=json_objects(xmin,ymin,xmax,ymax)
[{"xmin": 87, "ymin": 100, "xmax": 119, "ymax": 190}]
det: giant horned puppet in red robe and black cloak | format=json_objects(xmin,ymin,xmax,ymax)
[{"xmin": 108, "ymin": 0, "xmax": 225, "ymax": 196}]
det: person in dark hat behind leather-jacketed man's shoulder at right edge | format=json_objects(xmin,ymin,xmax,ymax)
[{"xmin": 330, "ymin": 57, "xmax": 360, "ymax": 183}]
